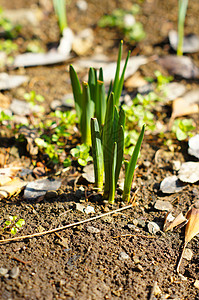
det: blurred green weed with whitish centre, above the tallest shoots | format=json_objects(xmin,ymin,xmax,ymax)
[{"xmin": 98, "ymin": 4, "xmax": 145, "ymax": 42}]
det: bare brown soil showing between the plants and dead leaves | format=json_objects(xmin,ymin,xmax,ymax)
[{"xmin": 0, "ymin": 0, "xmax": 199, "ymax": 300}]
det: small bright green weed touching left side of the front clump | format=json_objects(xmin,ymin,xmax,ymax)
[{"xmin": 70, "ymin": 144, "xmax": 93, "ymax": 167}]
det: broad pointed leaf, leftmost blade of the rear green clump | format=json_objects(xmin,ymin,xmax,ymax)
[{"xmin": 70, "ymin": 65, "xmax": 83, "ymax": 122}]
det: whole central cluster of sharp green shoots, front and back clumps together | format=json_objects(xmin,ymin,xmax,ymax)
[{"xmin": 70, "ymin": 42, "xmax": 145, "ymax": 203}]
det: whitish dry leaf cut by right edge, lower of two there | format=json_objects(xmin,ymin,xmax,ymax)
[{"xmin": 178, "ymin": 161, "xmax": 199, "ymax": 183}]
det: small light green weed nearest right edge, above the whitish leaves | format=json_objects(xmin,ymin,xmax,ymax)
[{"xmin": 172, "ymin": 119, "xmax": 195, "ymax": 141}]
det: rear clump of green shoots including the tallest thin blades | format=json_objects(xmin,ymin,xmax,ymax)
[{"xmin": 70, "ymin": 41, "xmax": 130, "ymax": 145}]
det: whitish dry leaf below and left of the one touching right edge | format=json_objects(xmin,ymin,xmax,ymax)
[{"xmin": 160, "ymin": 175, "xmax": 184, "ymax": 194}]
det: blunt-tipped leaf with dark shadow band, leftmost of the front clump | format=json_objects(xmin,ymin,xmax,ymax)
[{"xmin": 91, "ymin": 118, "xmax": 104, "ymax": 190}]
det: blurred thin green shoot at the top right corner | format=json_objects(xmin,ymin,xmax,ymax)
[{"xmin": 177, "ymin": 0, "xmax": 188, "ymax": 56}]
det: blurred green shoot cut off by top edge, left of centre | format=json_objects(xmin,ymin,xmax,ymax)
[{"xmin": 53, "ymin": 0, "xmax": 68, "ymax": 34}]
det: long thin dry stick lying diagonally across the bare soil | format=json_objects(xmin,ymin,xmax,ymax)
[{"xmin": 0, "ymin": 204, "xmax": 133, "ymax": 244}]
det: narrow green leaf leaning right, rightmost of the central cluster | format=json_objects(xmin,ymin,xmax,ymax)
[{"xmin": 123, "ymin": 125, "xmax": 145, "ymax": 201}]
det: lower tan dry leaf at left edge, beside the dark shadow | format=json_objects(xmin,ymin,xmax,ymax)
[{"xmin": 0, "ymin": 177, "xmax": 27, "ymax": 200}]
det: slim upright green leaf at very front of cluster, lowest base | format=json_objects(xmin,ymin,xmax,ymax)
[{"xmin": 108, "ymin": 143, "xmax": 117, "ymax": 204}]
